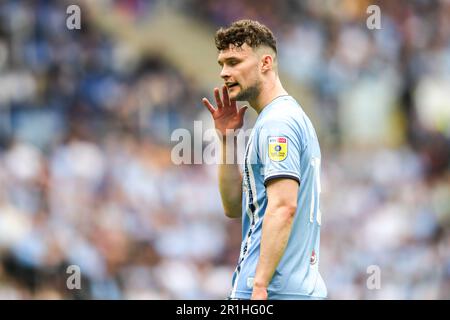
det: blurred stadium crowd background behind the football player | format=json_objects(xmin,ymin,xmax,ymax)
[{"xmin": 0, "ymin": 0, "xmax": 450, "ymax": 299}]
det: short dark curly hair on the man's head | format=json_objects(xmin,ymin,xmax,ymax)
[{"xmin": 215, "ymin": 20, "xmax": 277, "ymax": 53}]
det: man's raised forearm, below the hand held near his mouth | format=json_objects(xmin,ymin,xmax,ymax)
[{"xmin": 219, "ymin": 138, "xmax": 242, "ymax": 218}]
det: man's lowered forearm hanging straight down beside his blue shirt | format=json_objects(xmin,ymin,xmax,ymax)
[{"xmin": 253, "ymin": 207, "xmax": 295, "ymax": 289}]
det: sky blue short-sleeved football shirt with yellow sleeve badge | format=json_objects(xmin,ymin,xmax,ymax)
[{"xmin": 230, "ymin": 95, "xmax": 327, "ymax": 299}]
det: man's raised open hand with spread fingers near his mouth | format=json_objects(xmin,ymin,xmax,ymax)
[{"xmin": 202, "ymin": 85, "xmax": 248, "ymax": 136}]
